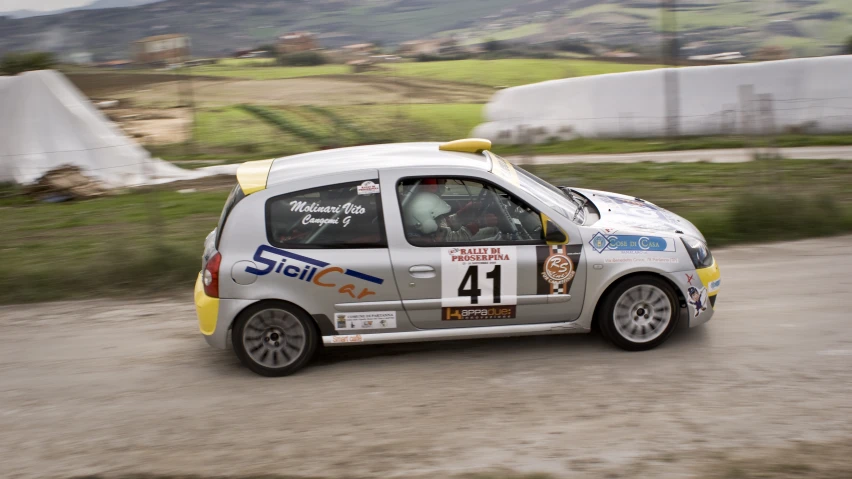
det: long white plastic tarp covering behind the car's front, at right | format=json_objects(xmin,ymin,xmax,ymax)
[{"xmin": 473, "ymin": 55, "xmax": 852, "ymax": 143}]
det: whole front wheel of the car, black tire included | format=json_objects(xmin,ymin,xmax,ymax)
[{"xmin": 598, "ymin": 275, "xmax": 680, "ymax": 351}]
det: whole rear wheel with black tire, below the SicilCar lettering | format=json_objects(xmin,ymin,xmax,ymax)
[{"xmin": 231, "ymin": 301, "xmax": 320, "ymax": 377}]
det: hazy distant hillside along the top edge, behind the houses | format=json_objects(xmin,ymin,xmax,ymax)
[{"xmin": 0, "ymin": 0, "xmax": 852, "ymax": 60}]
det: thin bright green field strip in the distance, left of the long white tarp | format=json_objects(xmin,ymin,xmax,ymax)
[{"xmin": 374, "ymin": 58, "xmax": 660, "ymax": 87}]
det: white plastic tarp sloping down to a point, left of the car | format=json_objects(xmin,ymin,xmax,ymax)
[{"xmin": 0, "ymin": 70, "xmax": 212, "ymax": 188}]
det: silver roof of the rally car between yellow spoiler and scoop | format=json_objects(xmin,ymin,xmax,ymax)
[{"xmin": 266, "ymin": 143, "xmax": 491, "ymax": 187}]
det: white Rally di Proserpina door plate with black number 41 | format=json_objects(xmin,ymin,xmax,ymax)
[{"xmin": 441, "ymin": 246, "xmax": 518, "ymax": 307}]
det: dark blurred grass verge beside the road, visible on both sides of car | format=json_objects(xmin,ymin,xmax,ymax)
[{"xmin": 0, "ymin": 160, "xmax": 852, "ymax": 303}]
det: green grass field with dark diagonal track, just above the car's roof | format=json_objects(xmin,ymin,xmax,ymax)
[{"xmin": 149, "ymin": 103, "xmax": 490, "ymax": 161}]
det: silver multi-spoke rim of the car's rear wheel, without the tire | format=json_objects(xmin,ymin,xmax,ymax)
[{"xmin": 243, "ymin": 309, "xmax": 306, "ymax": 368}]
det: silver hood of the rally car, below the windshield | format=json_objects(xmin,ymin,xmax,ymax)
[{"xmin": 571, "ymin": 188, "xmax": 706, "ymax": 242}]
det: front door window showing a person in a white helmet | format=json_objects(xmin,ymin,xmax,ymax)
[{"xmin": 397, "ymin": 177, "xmax": 545, "ymax": 246}]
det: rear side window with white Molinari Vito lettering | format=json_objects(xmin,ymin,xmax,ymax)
[{"xmin": 266, "ymin": 180, "xmax": 387, "ymax": 248}]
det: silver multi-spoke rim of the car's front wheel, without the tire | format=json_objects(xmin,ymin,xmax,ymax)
[{"xmin": 613, "ymin": 284, "xmax": 672, "ymax": 343}]
